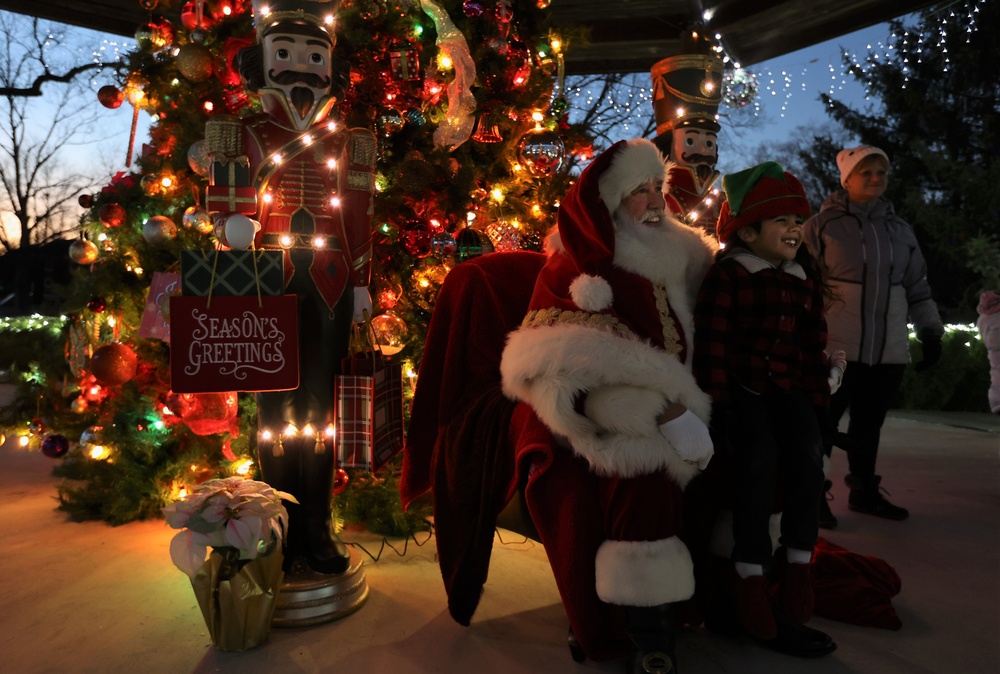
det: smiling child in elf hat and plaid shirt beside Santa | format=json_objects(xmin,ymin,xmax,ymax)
[{"xmin": 693, "ymin": 162, "xmax": 830, "ymax": 639}]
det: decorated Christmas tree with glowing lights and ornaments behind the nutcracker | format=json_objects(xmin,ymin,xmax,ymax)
[{"xmin": 0, "ymin": 0, "xmax": 592, "ymax": 533}]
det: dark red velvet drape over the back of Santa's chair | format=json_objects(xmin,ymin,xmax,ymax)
[{"xmin": 400, "ymin": 251, "xmax": 545, "ymax": 625}]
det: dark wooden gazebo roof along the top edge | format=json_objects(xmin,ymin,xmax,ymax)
[{"xmin": 0, "ymin": 0, "xmax": 934, "ymax": 74}]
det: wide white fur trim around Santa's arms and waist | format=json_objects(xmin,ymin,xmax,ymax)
[{"xmin": 500, "ymin": 324, "xmax": 711, "ymax": 486}]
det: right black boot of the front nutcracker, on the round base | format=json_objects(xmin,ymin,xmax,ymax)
[{"xmin": 301, "ymin": 439, "xmax": 351, "ymax": 574}]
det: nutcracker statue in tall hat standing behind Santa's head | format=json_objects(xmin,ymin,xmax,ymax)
[{"xmin": 651, "ymin": 31, "xmax": 723, "ymax": 236}]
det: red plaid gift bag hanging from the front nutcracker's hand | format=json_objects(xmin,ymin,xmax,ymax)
[{"xmin": 335, "ymin": 361, "xmax": 403, "ymax": 471}]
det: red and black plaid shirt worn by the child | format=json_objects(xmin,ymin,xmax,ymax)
[{"xmin": 693, "ymin": 255, "xmax": 830, "ymax": 406}]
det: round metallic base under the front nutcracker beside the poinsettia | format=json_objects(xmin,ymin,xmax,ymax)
[{"xmin": 271, "ymin": 550, "xmax": 368, "ymax": 627}]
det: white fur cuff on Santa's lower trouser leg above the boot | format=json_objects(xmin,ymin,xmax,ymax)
[{"xmin": 594, "ymin": 537, "xmax": 694, "ymax": 606}]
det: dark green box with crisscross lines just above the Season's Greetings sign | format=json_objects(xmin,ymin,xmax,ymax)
[{"xmin": 181, "ymin": 249, "xmax": 285, "ymax": 297}]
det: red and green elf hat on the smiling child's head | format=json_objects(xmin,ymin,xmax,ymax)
[{"xmin": 716, "ymin": 161, "xmax": 812, "ymax": 243}]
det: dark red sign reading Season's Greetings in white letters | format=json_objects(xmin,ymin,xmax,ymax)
[{"xmin": 170, "ymin": 295, "xmax": 299, "ymax": 393}]
